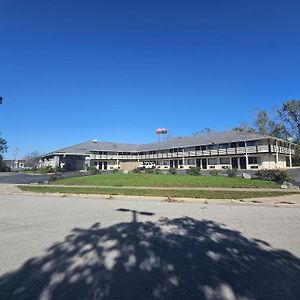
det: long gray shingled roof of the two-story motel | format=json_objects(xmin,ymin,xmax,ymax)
[{"xmin": 48, "ymin": 131, "xmax": 271, "ymax": 155}]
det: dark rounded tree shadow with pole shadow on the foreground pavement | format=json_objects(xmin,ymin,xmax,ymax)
[{"xmin": 0, "ymin": 209, "xmax": 300, "ymax": 300}]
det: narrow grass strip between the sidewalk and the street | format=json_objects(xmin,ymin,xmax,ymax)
[{"xmin": 18, "ymin": 186, "xmax": 292, "ymax": 199}]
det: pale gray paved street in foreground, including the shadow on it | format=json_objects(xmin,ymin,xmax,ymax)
[{"xmin": 0, "ymin": 194, "xmax": 300, "ymax": 300}]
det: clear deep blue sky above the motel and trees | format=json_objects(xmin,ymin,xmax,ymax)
[{"xmin": 0, "ymin": 0, "xmax": 300, "ymax": 158}]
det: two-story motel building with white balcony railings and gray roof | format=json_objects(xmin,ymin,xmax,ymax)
[{"xmin": 41, "ymin": 131, "xmax": 295, "ymax": 170}]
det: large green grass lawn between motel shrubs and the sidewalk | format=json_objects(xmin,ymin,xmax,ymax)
[{"xmin": 54, "ymin": 173, "xmax": 278, "ymax": 188}]
